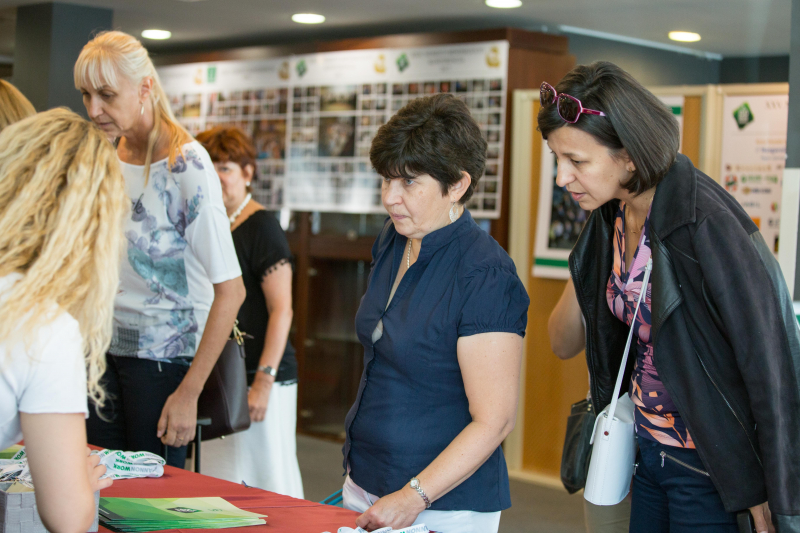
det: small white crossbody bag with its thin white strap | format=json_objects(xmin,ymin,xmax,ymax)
[{"xmin": 583, "ymin": 257, "xmax": 653, "ymax": 505}]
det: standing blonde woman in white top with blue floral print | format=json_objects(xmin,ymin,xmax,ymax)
[{"xmin": 75, "ymin": 31, "xmax": 245, "ymax": 468}]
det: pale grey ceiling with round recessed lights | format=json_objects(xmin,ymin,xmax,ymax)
[{"xmin": 0, "ymin": 0, "xmax": 791, "ymax": 56}]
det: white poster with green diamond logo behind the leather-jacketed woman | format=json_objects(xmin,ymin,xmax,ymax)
[{"xmin": 720, "ymin": 94, "xmax": 789, "ymax": 256}]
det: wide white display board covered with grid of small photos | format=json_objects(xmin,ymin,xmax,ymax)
[{"xmin": 158, "ymin": 41, "xmax": 508, "ymax": 218}]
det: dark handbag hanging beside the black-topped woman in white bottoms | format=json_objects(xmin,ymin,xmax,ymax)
[{"xmin": 197, "ymin": 321, "xmax": 250, "ymax": 440}]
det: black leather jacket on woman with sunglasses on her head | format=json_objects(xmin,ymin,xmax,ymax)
[{"xmin": 569, "ymin": 155, "xmax": 800, "ymax": 533}]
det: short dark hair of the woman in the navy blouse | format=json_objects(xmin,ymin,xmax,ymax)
[{"xmin": 369, "ymin": 94, "xmax": 486, "ymax": 204}]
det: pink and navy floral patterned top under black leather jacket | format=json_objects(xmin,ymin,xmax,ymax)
[{"xmin": 606, "ymin": 202, "xmax": 695, "ymax": 448}]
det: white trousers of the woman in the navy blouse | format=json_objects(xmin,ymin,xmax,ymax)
[{"xmin": 342, "ymin": 476, "xmax": 500, "ymax": 533}]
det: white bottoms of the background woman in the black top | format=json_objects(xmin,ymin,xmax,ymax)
[{"xmin": 205, "ymin": 382, "xmax": 303, "ymax": 498}]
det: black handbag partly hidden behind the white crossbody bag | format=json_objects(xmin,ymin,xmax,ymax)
[{"xmin": 561, "ymin": 400, "xmax": 597, "ymax": 494}]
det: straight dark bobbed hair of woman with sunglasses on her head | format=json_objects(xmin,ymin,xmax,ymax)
[{"xmin": 538, "ymin": 61, "xmax": 680, "ymax": 194}]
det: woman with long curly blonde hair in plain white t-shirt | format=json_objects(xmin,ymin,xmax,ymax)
[{"xmin": 0, "ymin": 109, "xmax": 127, "ymax": 532}]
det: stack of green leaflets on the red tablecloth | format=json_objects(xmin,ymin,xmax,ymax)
[{"xmin": 100, "ymin": 498, "xmax": 267, "ymax": 531}]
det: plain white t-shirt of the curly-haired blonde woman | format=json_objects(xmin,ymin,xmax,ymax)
[{"xmin": 0, "ymin": 274, "xmax": 89, "ymax": 450}]
